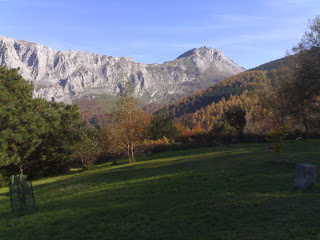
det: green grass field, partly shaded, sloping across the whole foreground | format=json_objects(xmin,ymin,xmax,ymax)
[{"xmin": 0, "ymin": 140, "xmax": 320, "ymax": 240}]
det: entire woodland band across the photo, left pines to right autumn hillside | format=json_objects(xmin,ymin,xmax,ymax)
[{"xmin": 0, "ymin": 17, "xmax": 320, "ymax": 183}]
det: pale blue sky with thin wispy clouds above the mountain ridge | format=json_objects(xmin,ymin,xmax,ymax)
[{"xmin": 0, "ymin": 0, "xmax": 320, "ymax": 69}]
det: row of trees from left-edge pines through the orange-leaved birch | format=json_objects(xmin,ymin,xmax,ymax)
[{"xmin": 0, "ymin": 67, "xmax": 177, "ymax": 184}]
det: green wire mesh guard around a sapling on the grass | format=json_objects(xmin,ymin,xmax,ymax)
[{"xmin": 9, "ymin": 174, "xmax": 36, "ymax": 213}]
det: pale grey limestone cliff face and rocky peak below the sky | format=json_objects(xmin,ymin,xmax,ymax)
[{"xmin": 0, "ymin": 36, "xmax": 245, "ymax": 103}]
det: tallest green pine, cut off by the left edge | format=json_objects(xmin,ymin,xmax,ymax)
[{"xmin": 0, "ymin": 67, "xmax": 48, "ymax": 173}]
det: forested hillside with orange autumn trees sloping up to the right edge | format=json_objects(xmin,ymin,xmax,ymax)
[{"xmin": 159, "ymin": 17, "xmax": 320, "ymax": 138}]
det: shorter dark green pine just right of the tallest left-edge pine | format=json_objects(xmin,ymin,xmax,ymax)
[{"xmin": 26, "ymin": 100, "xmax": 85, "ymax": 177}]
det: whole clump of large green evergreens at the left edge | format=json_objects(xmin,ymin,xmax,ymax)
[{"xmin": 0, "ymin": 67, "xmax": 82, "ymax": 179}]
